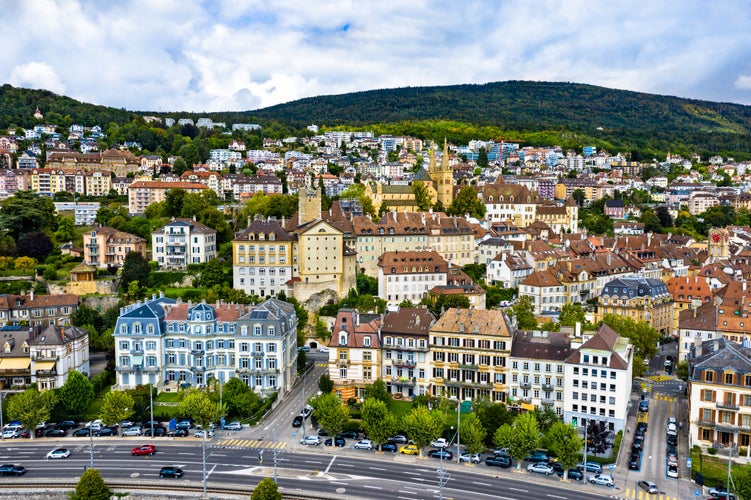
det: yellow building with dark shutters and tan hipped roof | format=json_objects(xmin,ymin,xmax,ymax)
[{"xmin": 429, "ymin": 309, "xmax": 511, "ymax": 402}]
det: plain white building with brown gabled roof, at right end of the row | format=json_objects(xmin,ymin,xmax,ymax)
[{"xmin": 563, "ymin": 325, "xmax": 634, "ymax": 432}]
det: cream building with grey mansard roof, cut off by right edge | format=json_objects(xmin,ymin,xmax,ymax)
[{"xmin": 688, "ymin": 338, "xmax": 751, "ymax": 455}]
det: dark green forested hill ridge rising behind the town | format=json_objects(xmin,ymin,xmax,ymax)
[{"xmin": 0, "ymin": 81, "xmax": 751, "ymax": 159}]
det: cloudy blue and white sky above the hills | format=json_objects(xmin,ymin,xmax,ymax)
[{"xmin": 5, "ymin": 0, "xmax": 751, "ymax": 112}]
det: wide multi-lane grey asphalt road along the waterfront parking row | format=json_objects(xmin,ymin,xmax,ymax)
[{"xmin": 0, "ymin": 438, "xmax": 613, "ymax": 500}]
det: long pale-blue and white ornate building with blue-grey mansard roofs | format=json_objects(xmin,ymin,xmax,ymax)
[{"xmin": 114, "ymin": 296, "xmax": 297, "ymax": 395}]
